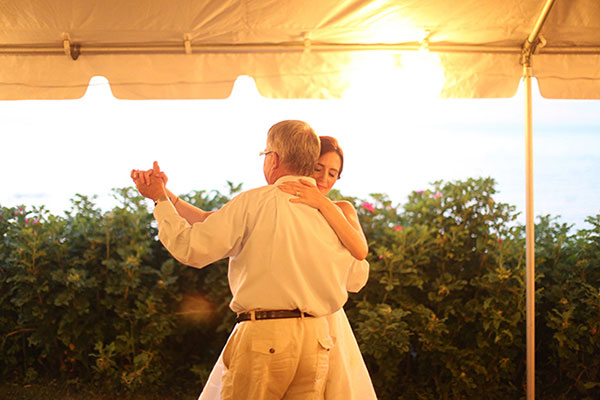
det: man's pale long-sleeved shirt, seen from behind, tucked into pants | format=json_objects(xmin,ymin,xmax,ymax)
[{"xmin": 154, "ymin": 176, "xmax": 369, "ymax": 316}]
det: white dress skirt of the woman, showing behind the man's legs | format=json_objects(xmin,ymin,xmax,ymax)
[{"xmin": 198, "ymin": 308, "xmax": 377, "ymax": 400}]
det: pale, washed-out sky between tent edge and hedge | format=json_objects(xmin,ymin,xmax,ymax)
[{"xmin": 0, "ymin": 78, "xmax": 600, "ymax": 228}]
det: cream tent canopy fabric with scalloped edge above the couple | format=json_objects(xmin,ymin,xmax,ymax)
[{"xmin": 0, "ymin": 0, "xmax": 600, "ymax": 100}]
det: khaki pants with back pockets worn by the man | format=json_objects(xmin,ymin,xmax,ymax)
[{"xmin": 221, "ymin": 318, "xmax": 333, "ymax": 400}]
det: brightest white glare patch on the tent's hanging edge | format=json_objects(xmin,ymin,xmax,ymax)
[{"xmin": 344, "ymin": 50, "xmax": 444, "ymax": 103}]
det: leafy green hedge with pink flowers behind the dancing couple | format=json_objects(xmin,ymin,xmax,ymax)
[{"xmin": 0, "ymin": 178, "xmax": 600, "ymax": 399}]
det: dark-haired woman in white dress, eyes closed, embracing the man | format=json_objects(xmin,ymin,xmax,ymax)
[{"xmin": 132, "ymin": 136, "xmax": 376, "ymax": 400}]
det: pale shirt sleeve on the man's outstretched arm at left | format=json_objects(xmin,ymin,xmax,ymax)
[{"xmin": 154, "ymin": 196, "xmax": 245, "ymax": 268}]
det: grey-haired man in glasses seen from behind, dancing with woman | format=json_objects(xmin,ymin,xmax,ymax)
[{"xmin": 135, "ymin": 121, "xmax": 368, "ymax": 399}]
